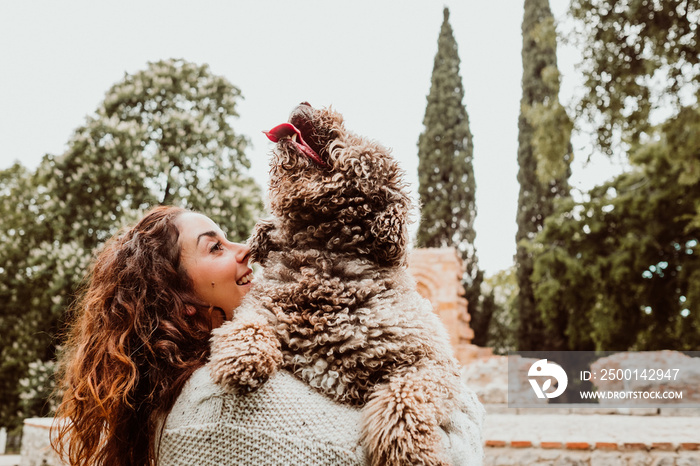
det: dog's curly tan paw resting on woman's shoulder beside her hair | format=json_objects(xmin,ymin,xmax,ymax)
[{"xmin": 209, "ymin": 316, "xmax": 282, "ymax": 393}]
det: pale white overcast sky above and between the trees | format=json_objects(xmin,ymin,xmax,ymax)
[{"xmin": 0, "ymin": 0, "xmax": 618, "ymax": 275}]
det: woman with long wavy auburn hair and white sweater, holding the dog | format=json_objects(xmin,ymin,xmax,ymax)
[{"xmin": 55, "ymin": 207, "xmax": 483, "ymax": 465}]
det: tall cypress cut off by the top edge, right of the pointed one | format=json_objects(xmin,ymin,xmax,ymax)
[{"xmin": 515, "ymin": 0, "xmax": 572, "ymax": 351}]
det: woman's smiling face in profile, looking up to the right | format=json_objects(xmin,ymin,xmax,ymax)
[{"xmin": 175, "ymin": 212, "xmax": 253, "ymax": 327}]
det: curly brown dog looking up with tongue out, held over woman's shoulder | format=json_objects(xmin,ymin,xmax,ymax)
[{"xmin": 211, "ymin": 103, "xmax": 463, "ymax": 465}]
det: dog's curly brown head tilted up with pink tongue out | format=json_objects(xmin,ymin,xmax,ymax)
[{"xmin": 266, "ymin": 103, "xmax": 411, "ymax": 266}]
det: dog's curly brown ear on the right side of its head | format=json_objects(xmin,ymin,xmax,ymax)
[{"xmin": 371, "ymin": 194, "xmax": 410, "ymax": 266}]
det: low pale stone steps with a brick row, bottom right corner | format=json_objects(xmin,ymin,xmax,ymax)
[{"xmin": 484, "ymin": 410, "xmax": 700, "ymax": 466}]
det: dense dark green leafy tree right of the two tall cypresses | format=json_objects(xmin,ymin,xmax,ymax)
[{"xmin": 530, "ymin": 108, "xmax": 700, "ymax": 350}]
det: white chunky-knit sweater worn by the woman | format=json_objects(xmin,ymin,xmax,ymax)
[{"xmin": 158, "ymin": 366, "xmax": 484, "ymax": 466}]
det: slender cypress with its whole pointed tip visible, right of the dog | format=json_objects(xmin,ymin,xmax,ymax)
[{"xmin": 417, "ymin": 8, "xmax": 483, "ymax": 334}]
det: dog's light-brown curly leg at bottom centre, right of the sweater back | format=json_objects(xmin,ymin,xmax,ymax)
[{"xmin": 362, "ymin": 361, "xmax": 459, "ymax": 466}]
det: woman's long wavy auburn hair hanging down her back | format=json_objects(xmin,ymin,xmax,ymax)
[{"xmin": 52, "ymin": 206, "xmax": 211, "ymax": 466}]
